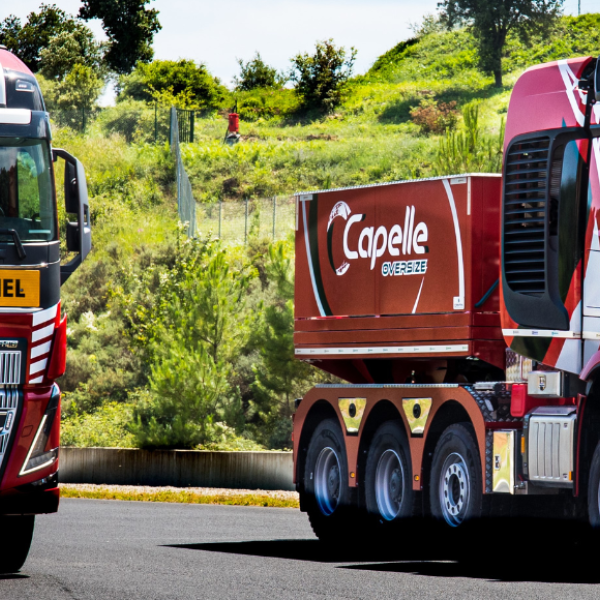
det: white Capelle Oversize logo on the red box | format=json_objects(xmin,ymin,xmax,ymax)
[{"xmin": 327, "ymin": 202, "xmax": 429, "ymax": 275}]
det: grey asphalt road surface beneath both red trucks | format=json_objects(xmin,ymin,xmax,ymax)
[{"xmin": 0, "ymin": 500, "xmax": 600, "ymax": 600}]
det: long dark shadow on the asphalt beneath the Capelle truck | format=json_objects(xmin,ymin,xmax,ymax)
[{"xmin": 168, "ymin": 529, "xmax": 600, "ymax": 584}]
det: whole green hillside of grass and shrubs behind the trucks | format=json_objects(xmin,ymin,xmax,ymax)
[{"xmin": 55, "ymin": 15, "xmax": 600, "ymax": 449}]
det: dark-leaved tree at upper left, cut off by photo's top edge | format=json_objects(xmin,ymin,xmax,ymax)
[{"xmin": 79, "ymin": 0, "xmax": 162, "ymax": 74}]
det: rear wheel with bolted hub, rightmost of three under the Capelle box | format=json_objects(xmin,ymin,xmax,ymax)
[{"xmin": 430, "ymin": 423, "xmax": 483, "ymax": 527}]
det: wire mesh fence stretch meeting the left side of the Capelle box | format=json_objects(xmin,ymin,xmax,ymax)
[{"xmin": 196, "ymin": 196, "xmax": 296, "ymax": 243}]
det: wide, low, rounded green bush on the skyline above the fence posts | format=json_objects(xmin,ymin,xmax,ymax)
[{"xmin": 119, "ymin": 59, "xmax": 227, "ymax": 108}]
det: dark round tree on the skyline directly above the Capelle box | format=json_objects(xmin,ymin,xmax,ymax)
[{"xmin": 291, "ymin": 39, "xmax": 356, "ymax": 111}]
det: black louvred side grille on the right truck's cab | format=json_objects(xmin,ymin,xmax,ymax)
[{"xmin": 503, "ymin": 137, "xmax": 550, "ymax": 297}]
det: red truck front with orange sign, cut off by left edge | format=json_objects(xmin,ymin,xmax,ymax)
[{"xmin": 0, "ymin": 47, "xmax": 91, "ymax": 573}]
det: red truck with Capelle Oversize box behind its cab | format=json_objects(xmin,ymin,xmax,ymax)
[{"xmin": 293, "ymin": 57, "xmax": 600, "ymax": 539}]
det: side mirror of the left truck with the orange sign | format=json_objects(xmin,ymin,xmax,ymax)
[{"xmin": 52, "ymin": 148, "xmax": 92, "ymax": 284}]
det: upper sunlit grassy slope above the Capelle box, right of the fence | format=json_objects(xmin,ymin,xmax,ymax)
[{"xmin": 184, "ymin": 14, "xmax": 600, "ymax": 202}]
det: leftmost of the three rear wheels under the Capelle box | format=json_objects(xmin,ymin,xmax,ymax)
[{"xmin": 303, "ymin": 419, "xmax": 350, "ymax": 542}]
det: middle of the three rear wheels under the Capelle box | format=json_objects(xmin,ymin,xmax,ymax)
[{"xmin": 365, "ymin": 421, "xmax": 415, "ymax": 528}]
